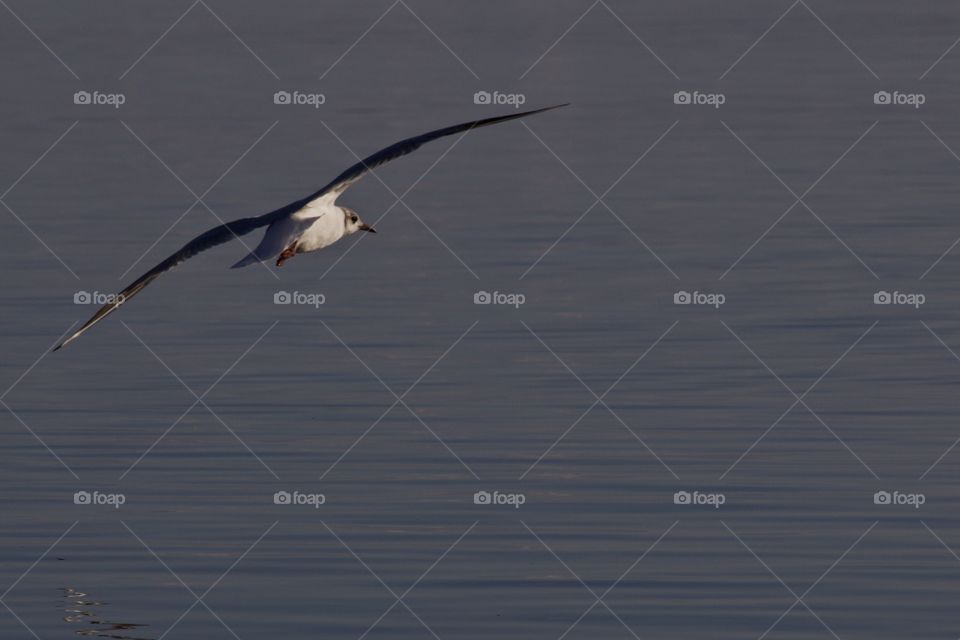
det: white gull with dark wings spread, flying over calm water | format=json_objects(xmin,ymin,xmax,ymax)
[{"xmin": 54, "ymin": 104, "xmax": 567, "ymax": 351}]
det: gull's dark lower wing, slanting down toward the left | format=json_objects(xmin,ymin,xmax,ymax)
[{"xmin": 54, "ymin": 209, "xmax": 290, "ymax": 351}]
